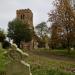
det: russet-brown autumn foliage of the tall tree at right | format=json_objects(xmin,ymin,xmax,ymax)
[{"xmin": 49, "ymin": 0, "xmax": 75, "ymax": 52}]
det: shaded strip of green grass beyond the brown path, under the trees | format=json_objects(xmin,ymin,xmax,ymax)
[{"xmin": 33, "ymin": 48, "xmax": 75, "ymax": 58}]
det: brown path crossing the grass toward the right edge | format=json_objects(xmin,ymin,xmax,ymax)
[{"xmin": 29, "ymin": 50, "xmax": 75, "ymax": 62}]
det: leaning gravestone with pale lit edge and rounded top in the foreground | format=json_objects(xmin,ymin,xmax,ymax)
[{"xmin": 6, "ymin": 45, "xmax": 32, "ymax": 75}]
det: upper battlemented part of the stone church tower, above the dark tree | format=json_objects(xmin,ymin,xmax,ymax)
[{"xmin": 16, "ymin": 9, "xmax": 33, "ymax": 29}]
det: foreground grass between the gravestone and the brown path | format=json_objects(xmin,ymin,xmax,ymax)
[{"xmin": 25, "ymin": 51, "xmax": 75, "ymax": 75}]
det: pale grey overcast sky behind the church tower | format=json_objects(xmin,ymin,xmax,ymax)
[{"xmin": 0, "ymin": 0, "xmax": 53, "ymax": 30}]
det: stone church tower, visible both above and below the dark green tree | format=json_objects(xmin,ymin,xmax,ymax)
[{"xmin": 16, "ymin": 9, "xmax": 33, "ymax": 49}]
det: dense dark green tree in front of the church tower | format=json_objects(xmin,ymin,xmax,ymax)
[{"xmin": 8, "ymin": 19, "xmax": 32, "ymax": 47}]
